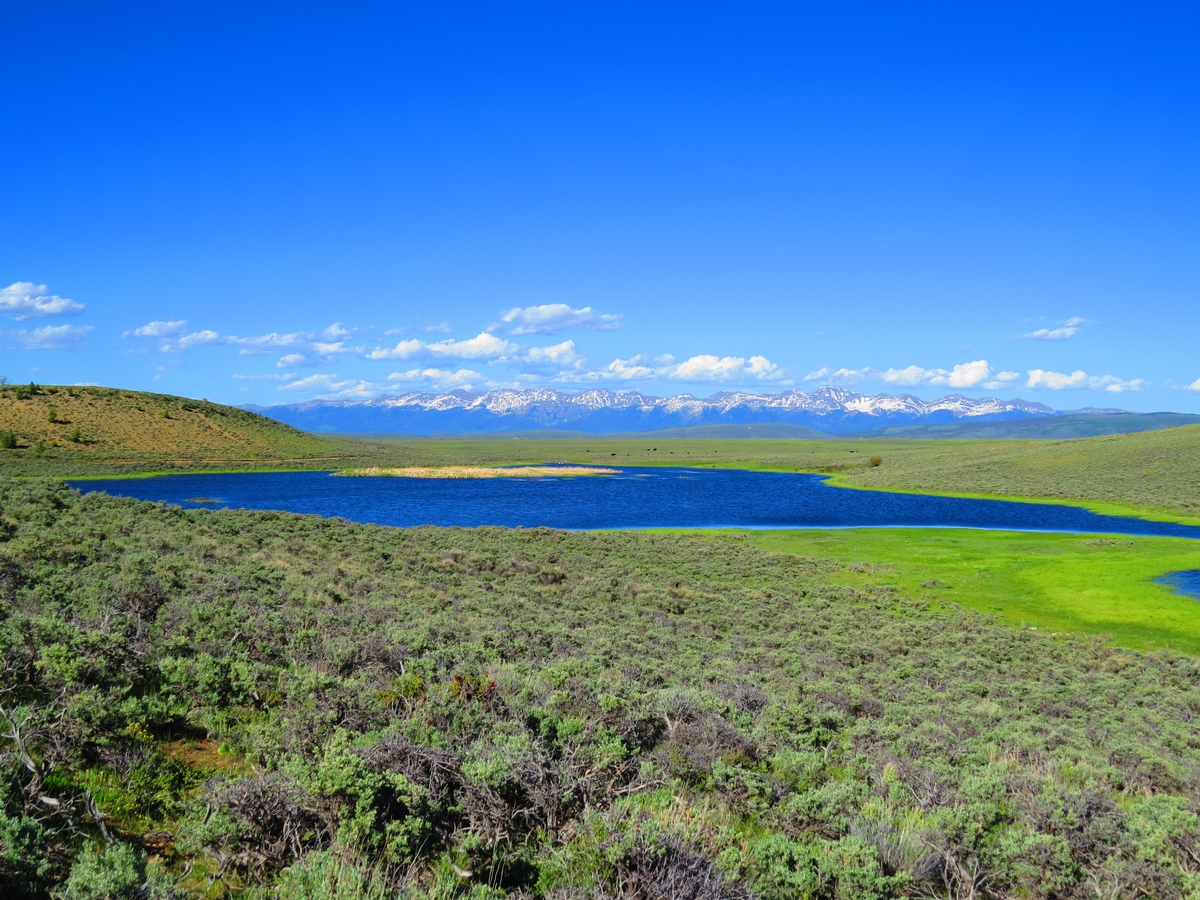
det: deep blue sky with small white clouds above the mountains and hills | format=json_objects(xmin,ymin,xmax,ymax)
[{"xmin": 0, "ymin": 0, "xmax": 1200, "ymax": 412}]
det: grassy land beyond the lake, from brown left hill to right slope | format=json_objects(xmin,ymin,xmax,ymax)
[{"xmin": 9, "ymin": 386, "xmax": 1200, "ymax": 517}]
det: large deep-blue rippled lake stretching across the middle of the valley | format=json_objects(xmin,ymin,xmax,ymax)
[{"xmin": 70, "ymin": 468, "xmax": 1200, "ymax": 538}]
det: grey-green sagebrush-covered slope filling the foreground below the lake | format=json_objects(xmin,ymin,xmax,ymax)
[{"xmin": 7, "ymin": 479, "xmax": 1200, "ymax": 900}]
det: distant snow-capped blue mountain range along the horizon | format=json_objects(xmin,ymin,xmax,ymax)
[{"xmin": 246, "ymin": 385, "xmax": 1121, "ymax": 434}]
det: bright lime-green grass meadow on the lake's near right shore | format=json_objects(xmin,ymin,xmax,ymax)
[{"xmin": 749, "ymin": 528, "xmax": 1200, "ymax": 655}]
